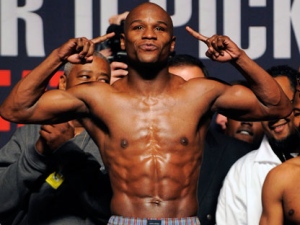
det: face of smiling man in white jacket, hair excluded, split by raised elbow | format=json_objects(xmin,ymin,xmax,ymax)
[{"xmin": 262, "ymin": 76, "xmax": 295, "ymax": 142}]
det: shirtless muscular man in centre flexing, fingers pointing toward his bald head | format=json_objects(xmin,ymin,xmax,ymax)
[{"xmin": 0, "ymin": 2, "xmax": 292, "ymax": 224}]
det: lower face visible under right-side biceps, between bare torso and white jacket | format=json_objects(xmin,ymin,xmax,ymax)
[{"xmin": 224, "ymin": 118, "xmax": 264, "ymax": 148}]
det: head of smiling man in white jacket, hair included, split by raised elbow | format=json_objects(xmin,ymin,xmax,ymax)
[{"xmin": 262, "ymin": 65, "xmax": 297, "ymax": 152}]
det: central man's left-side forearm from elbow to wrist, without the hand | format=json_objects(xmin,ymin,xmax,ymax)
[{"xmin": 0, "ymin": 49, "xmax": 63, "ymax": 121}]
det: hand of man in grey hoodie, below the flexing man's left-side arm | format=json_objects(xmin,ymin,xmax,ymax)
[{"xmin": 36, "ymin": 122, "xmax": 75, "ymax": 155}]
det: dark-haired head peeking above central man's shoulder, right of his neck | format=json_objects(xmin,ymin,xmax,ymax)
[{"xmin": 169, "ymin": 54, "xmax": 209, "ymax": 80}]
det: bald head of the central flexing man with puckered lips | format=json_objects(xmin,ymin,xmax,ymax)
[{"xmin": 121, "ymin": 2, "xmax": 175, "ymax": 65}]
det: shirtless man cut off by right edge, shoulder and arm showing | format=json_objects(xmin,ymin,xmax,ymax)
[{"xmin": 259, "ymin": 85, "xmax": 300, "ymax": 225}]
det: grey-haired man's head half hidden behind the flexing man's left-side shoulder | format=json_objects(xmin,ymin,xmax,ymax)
[{"xmin": 59, "ymin": 52, "xmax": 110, "ymax": 90}]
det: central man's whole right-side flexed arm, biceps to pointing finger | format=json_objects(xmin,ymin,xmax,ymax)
[{"xmin": 186, "ymin": 27, "xmax": 296, "ymax": 120}]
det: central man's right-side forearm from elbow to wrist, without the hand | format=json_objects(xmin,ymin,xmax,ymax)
[{"xmin": 232, "ymin": 51, "xmax": 292, "ymax": 117}]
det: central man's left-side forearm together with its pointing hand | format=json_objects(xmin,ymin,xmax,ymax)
[{"xmin": 0, "ymin": 33, "xmax": 114, "ymax": 123}]
